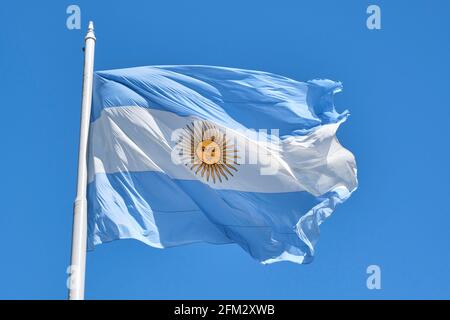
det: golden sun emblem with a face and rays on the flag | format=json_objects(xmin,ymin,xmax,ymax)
[{"xmin": 177, "ymin": 121, "xmax": 239, "ymax": 183}]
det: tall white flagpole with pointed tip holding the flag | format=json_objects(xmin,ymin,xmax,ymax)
[{"xmin": 69, "ymin": 21, "xmax": 95, "ymax": 300}]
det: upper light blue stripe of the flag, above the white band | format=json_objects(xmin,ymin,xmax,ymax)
[{"xmin": 91, "ymin": 66, "xmax": 347, "ymax": 136}]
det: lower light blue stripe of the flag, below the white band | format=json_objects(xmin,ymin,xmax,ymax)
[{"xmin": 88, "ymin": 172, "xmax": 342, "ymax": 262}]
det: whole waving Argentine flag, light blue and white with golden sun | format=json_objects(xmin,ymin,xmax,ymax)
[{"xmin": 88, "ymin": 66, "xmax": 357, "ymax": 263}]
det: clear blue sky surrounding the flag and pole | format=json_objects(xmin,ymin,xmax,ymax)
[{"xmin": 0, "ymin": 0, "xmax": 450, "ymax": 299}]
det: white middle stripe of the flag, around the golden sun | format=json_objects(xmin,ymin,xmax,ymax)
[{"xmin": 89, "ymin": 106, "xmax": 356, "ymax": 195}]
